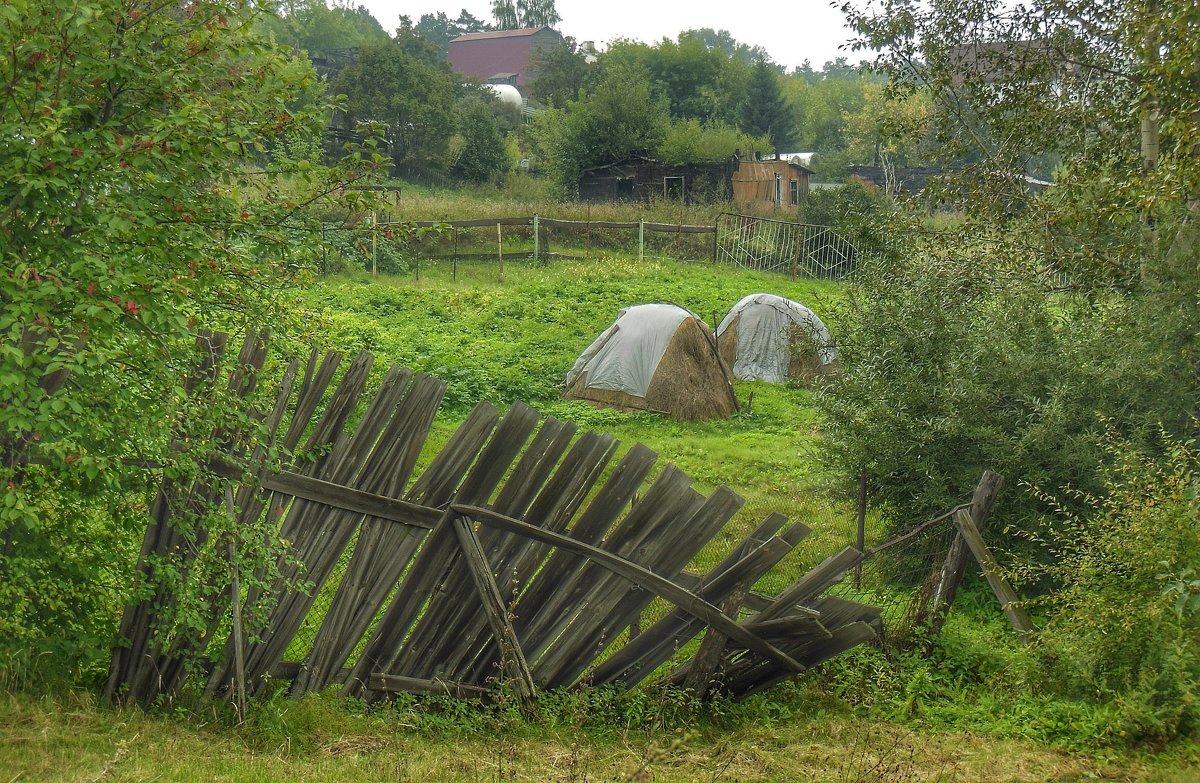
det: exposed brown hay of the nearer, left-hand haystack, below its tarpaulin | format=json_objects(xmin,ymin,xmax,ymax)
[{"xmin": 563, "ymin": 317, "xmax": 738, "ymax": 422}]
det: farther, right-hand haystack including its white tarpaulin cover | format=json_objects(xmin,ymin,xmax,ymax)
[{"xmin": 716, "ymin": 293, "xmax": 838, "ymax": 383}]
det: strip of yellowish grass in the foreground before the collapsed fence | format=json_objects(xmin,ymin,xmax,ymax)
[{"xmin": 0, "ymin": 689, "xmax": 1198, "ymax": 783}]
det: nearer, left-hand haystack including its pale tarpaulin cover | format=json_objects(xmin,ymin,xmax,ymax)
[{"xmin": 564, "ymin": 304, "xmax": 738, "ymax": 422}]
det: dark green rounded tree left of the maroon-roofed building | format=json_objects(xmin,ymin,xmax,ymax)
[{"xmin": 330, "ymin": 39, "xmax": 456, "ymax": 173}]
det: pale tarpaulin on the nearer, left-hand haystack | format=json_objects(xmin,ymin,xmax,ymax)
[{"xmin": 566, "ymin": 305, "xmax": 692, "ymax": 398}]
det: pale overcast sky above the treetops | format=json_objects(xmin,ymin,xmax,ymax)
[{"xmin": 352, "ymin": 0, "xmax": 862, "ymax": 70}]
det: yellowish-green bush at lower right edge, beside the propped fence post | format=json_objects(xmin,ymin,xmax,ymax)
[{"xmin": 1028, "ymin": 442, "xmax": 1200, "ymax": 743}]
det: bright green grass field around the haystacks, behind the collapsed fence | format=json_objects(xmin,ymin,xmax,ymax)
[{"xmin": 298, "ymin": 257, "xmax": 853, "ymax": 570}]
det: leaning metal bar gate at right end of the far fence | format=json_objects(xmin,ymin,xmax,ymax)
[{"xmin": 716, "ymin": 213, "xmax": 858, "ymax": 280}]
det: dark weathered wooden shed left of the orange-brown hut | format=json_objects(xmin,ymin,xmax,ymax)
[{"xmin": 580, "ymin": 157, "xmax": 734, "ymax": 203}]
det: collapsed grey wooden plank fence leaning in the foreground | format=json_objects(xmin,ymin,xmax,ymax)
[{"xmin": 106, "ymin": 336, "xmax": 882, "ymax": 704}]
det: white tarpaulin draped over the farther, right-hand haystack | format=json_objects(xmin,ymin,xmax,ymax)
[{"xmin": 716, "ymin": 294, "xmax": 838, "ymax": 383}]
